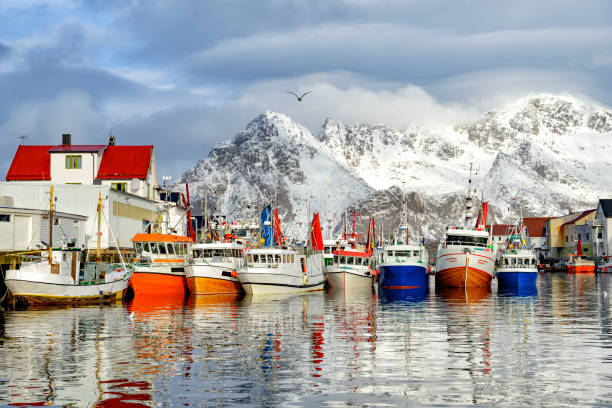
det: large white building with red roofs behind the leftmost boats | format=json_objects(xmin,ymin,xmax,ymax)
[{"xmin": 0, "ymin": 134, "xmax": 187, "ymax": 249}]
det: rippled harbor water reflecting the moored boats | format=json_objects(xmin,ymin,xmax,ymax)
[{"xmin": 0, "ymin": 273, "xmax": 612, "ymax": 407}]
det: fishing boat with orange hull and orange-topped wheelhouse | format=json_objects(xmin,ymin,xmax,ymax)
[{"xmin": 130, "ymin": 234, "xmax": 193, "ymax": 296}]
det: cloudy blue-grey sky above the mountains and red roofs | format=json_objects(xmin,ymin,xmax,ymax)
[{"xmin": 0, "ymin": 0, "xmax": 612, "ymax": 178}]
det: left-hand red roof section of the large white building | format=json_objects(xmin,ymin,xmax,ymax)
[{"xmin": 6, "ymin": 146, "xmax": 53, "ymax": 181}]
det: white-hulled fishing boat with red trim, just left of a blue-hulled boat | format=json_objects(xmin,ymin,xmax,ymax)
[{"xmin": 324, "ymin": 212, "xmax": 374, "ymax": 289}]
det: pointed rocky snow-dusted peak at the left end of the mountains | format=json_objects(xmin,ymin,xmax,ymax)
[{"xmin": 181, "ymin": 111, "xmax": 372, "ymax": 237}]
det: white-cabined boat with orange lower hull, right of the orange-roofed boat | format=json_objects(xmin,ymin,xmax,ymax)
[{"xmin": 185, "ymin": 238, "xmax": 246, "ymax": 295}]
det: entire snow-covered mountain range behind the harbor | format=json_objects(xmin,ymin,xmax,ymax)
[{"xmin": 182, "ymin": 95, "xmax": 612, "ymax": 238}]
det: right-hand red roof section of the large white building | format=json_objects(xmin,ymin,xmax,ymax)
[{"xmin": 98, "ymin": 146, "xmax": 153, "ymax": 180}]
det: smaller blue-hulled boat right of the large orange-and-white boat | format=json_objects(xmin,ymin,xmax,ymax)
[{"xmin": 496, "ymin": 224, "xmax": 538, "ymax": 294}]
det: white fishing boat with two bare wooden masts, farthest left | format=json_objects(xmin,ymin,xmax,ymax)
[{"xmin": 5, "ymin": 186, "xmax": 132, "ymax": 304}]
